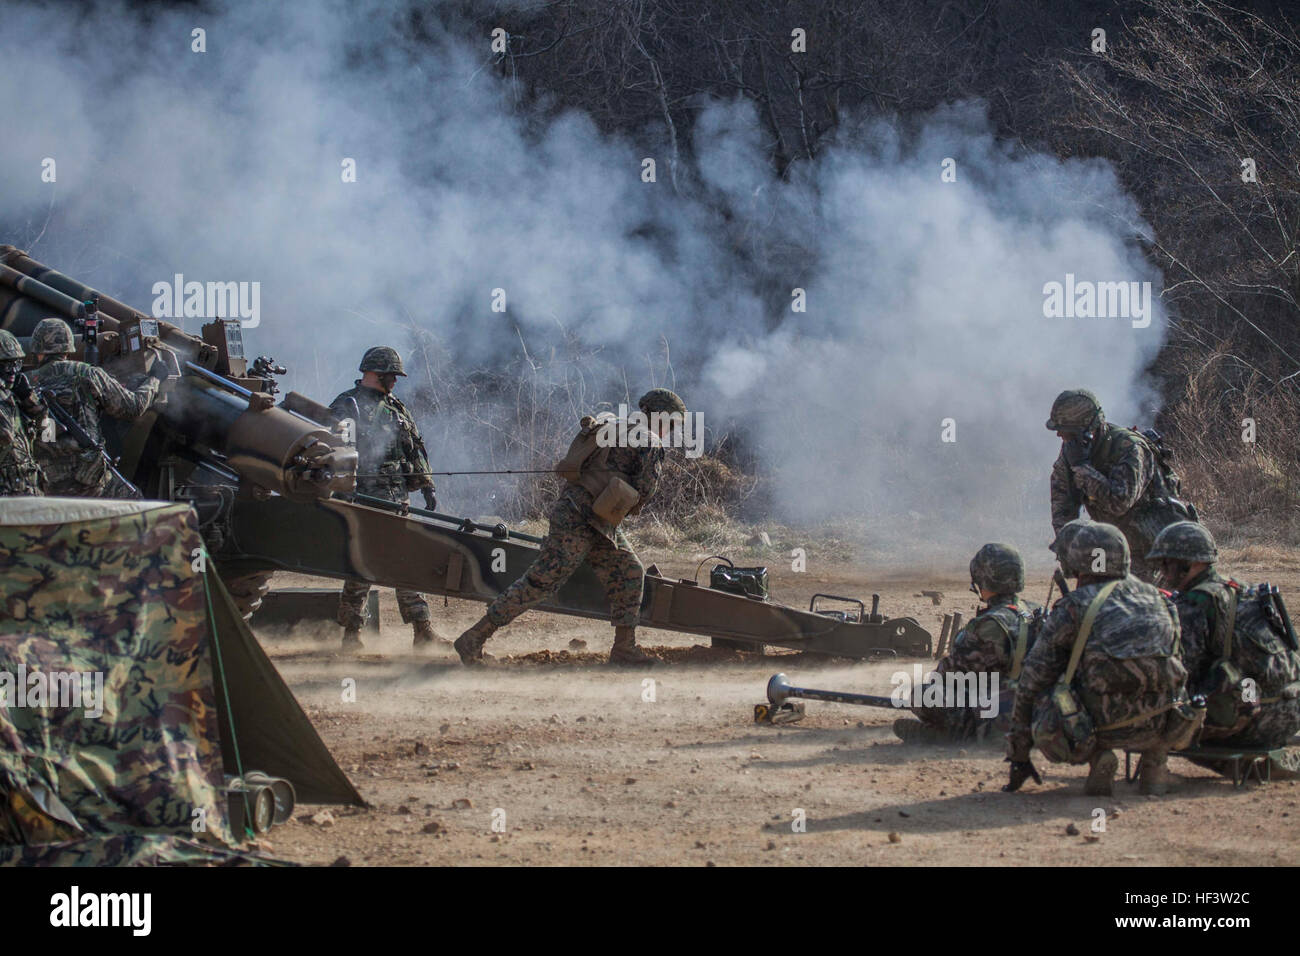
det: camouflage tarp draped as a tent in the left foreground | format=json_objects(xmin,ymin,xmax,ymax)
[{"xmin": 0, "ymin": 498, "xmax": 360, "ymax": 864}]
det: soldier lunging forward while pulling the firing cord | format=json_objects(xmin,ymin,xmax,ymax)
[{"xmin": 455, "ymin": 389, "xmax": 686, "ymax": 665}]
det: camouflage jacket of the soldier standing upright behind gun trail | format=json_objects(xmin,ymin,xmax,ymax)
[{"xmin": 330, "ymin": 380, "xmax": 433, "ymax": 503}]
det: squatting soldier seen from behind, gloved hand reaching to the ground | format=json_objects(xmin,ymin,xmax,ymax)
[{"xmin": 1006, "ymin": 523, "xmax": 1187, "ymax": 796}]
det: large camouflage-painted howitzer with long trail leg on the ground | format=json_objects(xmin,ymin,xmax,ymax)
[{"xmin": 0, "ymin": 246, "xmax": 932, "ymax": 657}]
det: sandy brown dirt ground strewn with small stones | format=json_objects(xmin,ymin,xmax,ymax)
[{"xmin": 250, "ymin": 551, "xmax": 1300, "ymax": 866}]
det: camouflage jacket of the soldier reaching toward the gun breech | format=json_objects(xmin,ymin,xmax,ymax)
[{"xmin": 27, "ymin": 359, "xmax": 159, "ymax": 494}]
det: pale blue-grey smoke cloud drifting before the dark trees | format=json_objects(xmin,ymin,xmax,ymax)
[{"xmin": 0, "ymin": 3, "xmax": 1165, "ymax": 554}]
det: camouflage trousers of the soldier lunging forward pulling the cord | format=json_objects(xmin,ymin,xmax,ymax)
[{"xmin": 488, "ymin": 497, "xmax": 645, "ymax": 627}]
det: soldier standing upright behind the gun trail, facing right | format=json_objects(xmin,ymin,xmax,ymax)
[{"xmin": 330, "ymin": 346, "xmax": 441, "ymax": 649}]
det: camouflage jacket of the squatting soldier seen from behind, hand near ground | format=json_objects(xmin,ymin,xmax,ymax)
[{"xmin": 1008, "ymin": 576, "xmax": 1187, "ymax": 760}]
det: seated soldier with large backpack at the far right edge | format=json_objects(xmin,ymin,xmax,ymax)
[{"xmin": 1147, "ymin": 522, "xmax": 1300, "ymax": 778}]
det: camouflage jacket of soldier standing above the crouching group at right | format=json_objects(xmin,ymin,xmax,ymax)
[{"xmin": 1052, "ymin": 424, "xmax": 1164, "ymax": 531}]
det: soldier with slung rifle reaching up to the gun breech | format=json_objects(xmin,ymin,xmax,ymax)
[{"xmin": 31, "ymin": 319, "xmax": 166, "ymax": 498}]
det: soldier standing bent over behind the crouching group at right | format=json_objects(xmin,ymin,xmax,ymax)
[{"xmin": 1047, "ymin": 389, "xmax": 1191, "ymax": 583}]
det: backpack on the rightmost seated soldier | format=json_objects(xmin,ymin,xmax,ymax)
[{"xmin": 1192, "ymin": 580, "xmax": 1300, "ymax": 727}]
